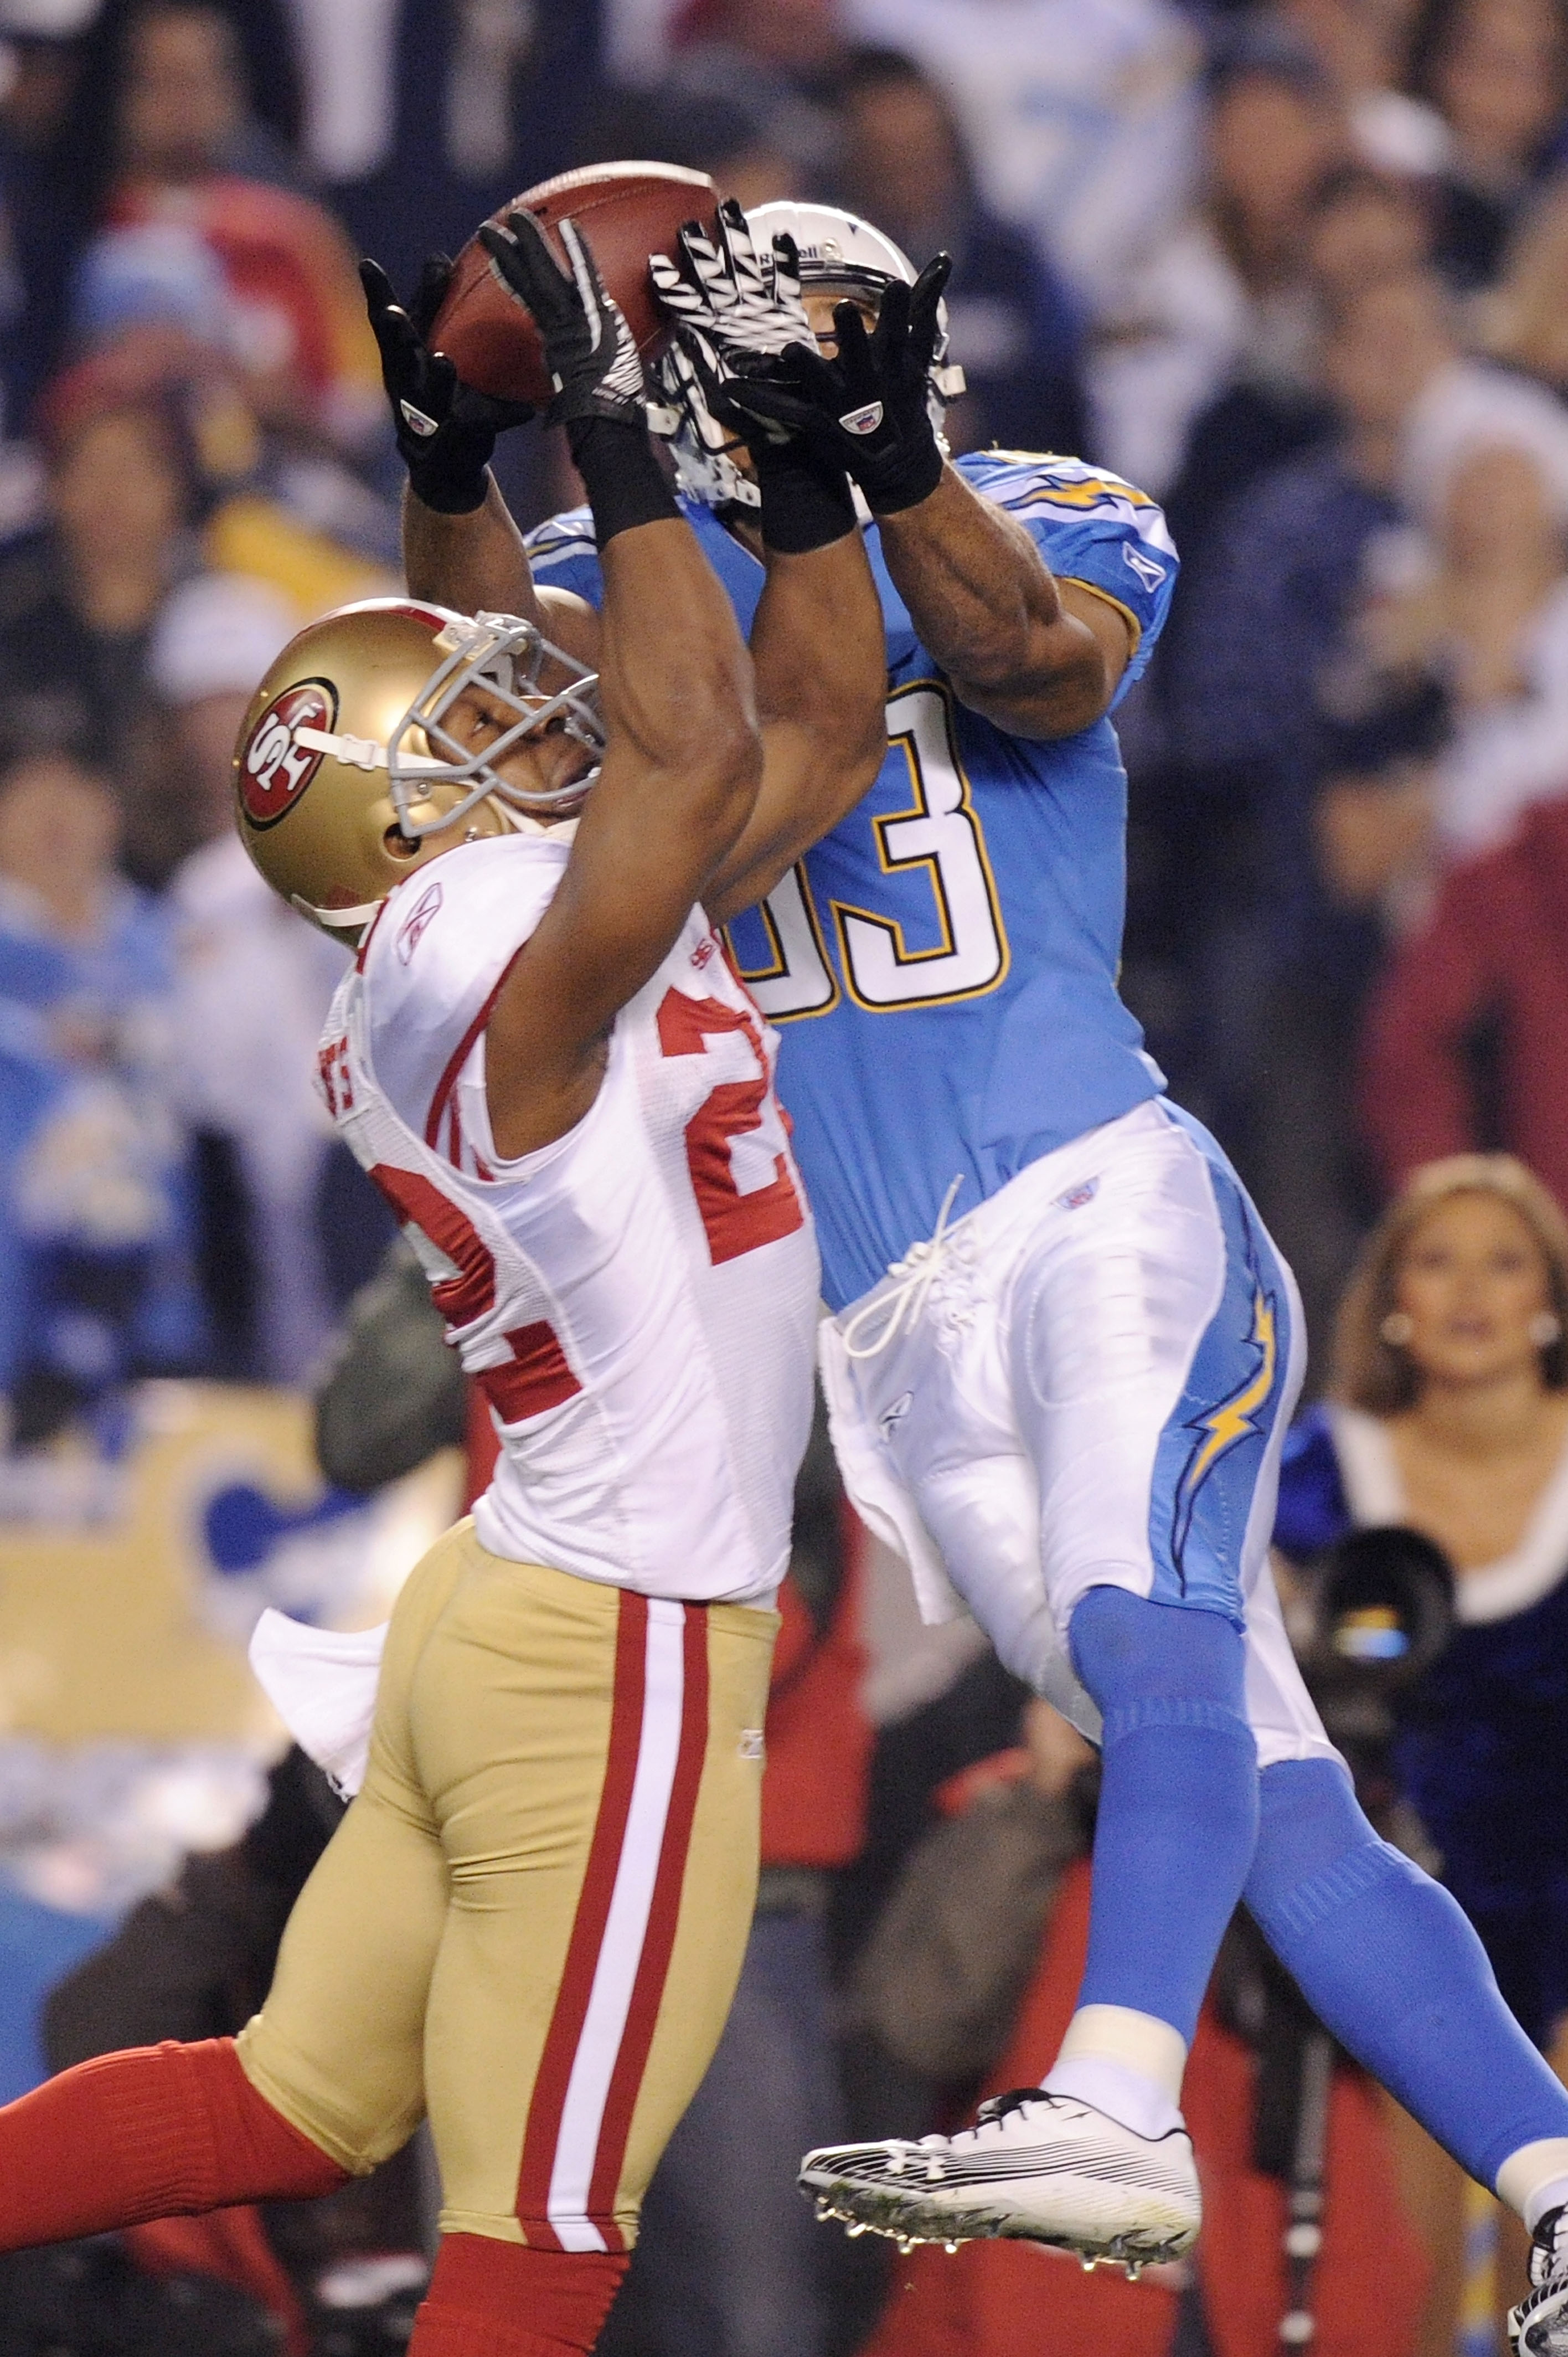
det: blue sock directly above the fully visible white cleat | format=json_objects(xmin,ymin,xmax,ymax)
[{"xmin": 1073, "ymin": 1589, "xmax": 1257, "ymax": 2046}]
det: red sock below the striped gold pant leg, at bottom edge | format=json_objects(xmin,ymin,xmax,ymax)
[{"xmin": 408, "ymin": 2235, "xmax": 630, "ymax": 2357}]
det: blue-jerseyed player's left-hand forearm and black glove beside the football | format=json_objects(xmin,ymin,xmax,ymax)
[{"xmin": 358, "ymin": 255, "xmax": 599, "ymax": 670}]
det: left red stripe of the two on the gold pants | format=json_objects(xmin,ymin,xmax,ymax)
[{"xmin": 517, "ymin": 1589, "xmax": 648, "ymax": 2251}]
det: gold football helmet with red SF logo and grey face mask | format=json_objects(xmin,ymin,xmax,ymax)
[{"xmin": 234, "ymin": 599, "xmax": 604, "ymax": 940}]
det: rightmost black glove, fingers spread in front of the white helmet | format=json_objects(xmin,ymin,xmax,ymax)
[{"xmin": 724, "ymin": 255, "xmax": 952, "ymax": 516}]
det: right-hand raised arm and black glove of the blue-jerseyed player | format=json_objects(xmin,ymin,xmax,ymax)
[{"xmin": 735, "ymin": 255, "xmax": 1132, "ymax": 738}]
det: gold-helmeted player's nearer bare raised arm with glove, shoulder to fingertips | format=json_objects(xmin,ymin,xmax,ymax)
[{"xmin": 483, "ymin": 212, "xmax": 762, "ymax": 1157}]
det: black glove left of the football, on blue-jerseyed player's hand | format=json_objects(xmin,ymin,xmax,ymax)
[{"xmin": 358, "ymin": 255, "xmax": 533, "ymax": 516}]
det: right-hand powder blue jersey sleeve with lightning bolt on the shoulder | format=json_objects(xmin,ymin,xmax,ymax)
[{"xmin": 957, "ymin": 450, "xmax": 1177, "ymax": 709}]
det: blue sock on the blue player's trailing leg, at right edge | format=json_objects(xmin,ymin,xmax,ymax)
[{"xmin": 1245, "ymin": 1761, "xmax": 1568, "ymax": 2188}]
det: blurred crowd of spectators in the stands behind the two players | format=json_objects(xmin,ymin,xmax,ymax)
[{"xmin": 0, "ymin": 0, "xmax": 1568, "ymax": 1440}]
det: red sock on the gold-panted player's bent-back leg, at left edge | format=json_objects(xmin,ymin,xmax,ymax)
[{"xmin": 0, "ymin": 2039, "xmax": 347, "ymax": 2251}]
